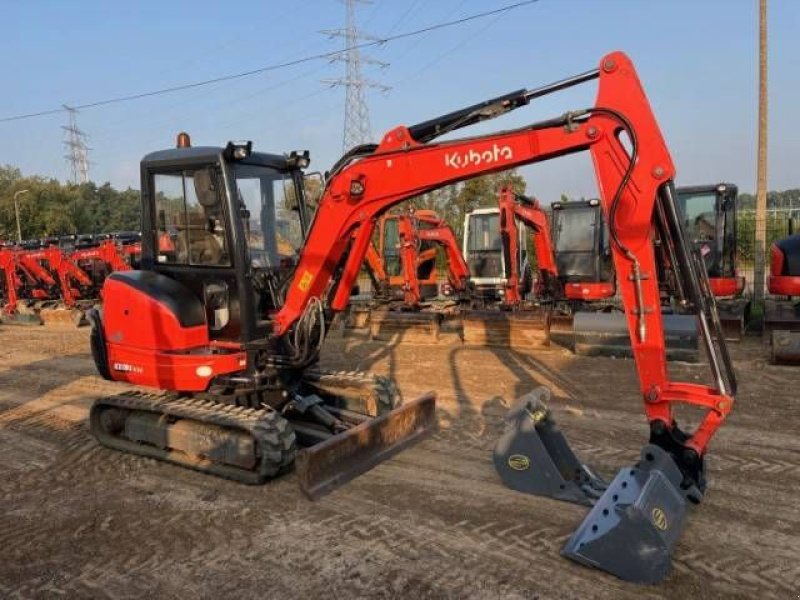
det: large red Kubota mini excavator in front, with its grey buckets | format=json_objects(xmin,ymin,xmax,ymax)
[{"xmin": 90, "ymin": 52, "xmax": 736, "ymax": 581}]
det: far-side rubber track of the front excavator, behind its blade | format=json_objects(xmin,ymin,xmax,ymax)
[{"xmin": 303, "ymin": 369, "xmax": 403, "ymax": 416}]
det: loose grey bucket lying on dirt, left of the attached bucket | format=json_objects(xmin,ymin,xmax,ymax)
[{"xmin": 494, "ymin": 387, "xmax": 607, "ymax": 506}]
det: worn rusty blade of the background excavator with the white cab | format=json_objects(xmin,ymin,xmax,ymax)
[{"xmin": 461, "ymin": 310, "xmax": 550, "ymax": 348}]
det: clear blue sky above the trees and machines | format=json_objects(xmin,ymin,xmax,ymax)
[{"xmin": 0, "ymin": 0, "xmax": 800, "ymax": 203}]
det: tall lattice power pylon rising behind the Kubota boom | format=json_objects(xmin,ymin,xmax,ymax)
[{"xmin": 321, "ymin": 0, "xmax": 391, "ymax": 152}]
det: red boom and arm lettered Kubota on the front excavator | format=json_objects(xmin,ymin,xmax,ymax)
[{"xmin": 274, "ymin": 52, "xmax": 735, "ymax": 468}]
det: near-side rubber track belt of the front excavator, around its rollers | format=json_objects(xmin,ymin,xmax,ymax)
[{"xmin": 89, "ymin": 391, "xmax": 297, "ymax": 485}]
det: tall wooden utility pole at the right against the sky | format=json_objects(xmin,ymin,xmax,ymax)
[{"xmin": 753, "ymin": 0, "xmax": 767, "ymax": 306}]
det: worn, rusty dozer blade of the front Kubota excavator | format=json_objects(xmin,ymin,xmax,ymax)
[{"xmin": 295, "ymin": 392, "xmax": 436, "ymax": 500}]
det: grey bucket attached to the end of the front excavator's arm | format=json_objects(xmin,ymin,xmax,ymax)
[{"xmin": 561, "ymin": 445, "xmax": 687, "ymax": 583}]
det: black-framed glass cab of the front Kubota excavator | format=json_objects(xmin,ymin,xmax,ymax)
[{"xmin": 139, "ymin": 144, "xmax": 308, "ymax": 343}]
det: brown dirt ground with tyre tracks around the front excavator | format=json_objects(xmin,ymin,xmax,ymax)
[{"xmin": 0, "ymin": 326, "xmax": 800, "ymax": 599}]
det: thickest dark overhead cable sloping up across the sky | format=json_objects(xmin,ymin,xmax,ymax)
[{"xmin": 0, "ymin": 0, "xmax": 539, "ymax": 123}]
